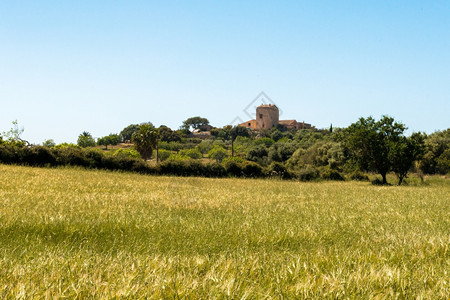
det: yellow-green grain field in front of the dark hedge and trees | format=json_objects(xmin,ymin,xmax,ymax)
[{"xmin": 0, "ymin": 165, "xmax": 450, "ymax": 299}]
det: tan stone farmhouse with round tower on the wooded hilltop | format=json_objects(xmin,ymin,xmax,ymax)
[{"xmin": 238, "ymin": 104, "xmax": 311, "ymax": 130}]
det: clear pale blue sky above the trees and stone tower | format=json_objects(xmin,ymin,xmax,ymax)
[{"xmin": 0, "ymin": 0, "xmax": 450, "ymax": 143}]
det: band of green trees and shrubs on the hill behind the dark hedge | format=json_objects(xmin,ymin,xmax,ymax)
[{"xmin": 0, "ymin": 116, "xmax": 450, "ymax": 184}]
